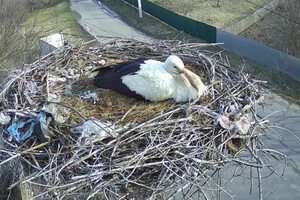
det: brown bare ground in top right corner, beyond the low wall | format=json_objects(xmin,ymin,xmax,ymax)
[{"xmin": 241, "ymin": 0, "xmax": 300, "ymax": 57}]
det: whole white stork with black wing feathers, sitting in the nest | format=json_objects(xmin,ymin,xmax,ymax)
[{"xmin": 94, "ymin": 55, "xmax": 206, "ymax": 102}]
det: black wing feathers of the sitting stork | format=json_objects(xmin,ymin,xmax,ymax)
[{"xmin": 94, "ymin": 58, "xmax": 148, "ymax": 100}]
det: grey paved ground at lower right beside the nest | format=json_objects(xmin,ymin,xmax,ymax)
[{"xmin": 222, "ymin": 93, "xmax": 300, "ymax": 200}]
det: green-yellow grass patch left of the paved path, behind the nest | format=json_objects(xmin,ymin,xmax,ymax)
[{"xmin": 24, "ymin": 0, "xmax": 91, "ymax": 44}]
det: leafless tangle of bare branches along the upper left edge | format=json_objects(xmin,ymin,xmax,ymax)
[{"xmin": 0, "ymin": 0, "xmax": 38, "ymax": 78}]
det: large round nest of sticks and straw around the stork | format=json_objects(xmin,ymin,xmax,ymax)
[{"xmin": 1, "ymin": 40, "xmax": 274, "ymax": 199}]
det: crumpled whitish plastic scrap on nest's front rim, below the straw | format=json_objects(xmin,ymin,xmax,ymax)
[{"xmin": 71, "ymin": 119, "xmax": 117, "ymax": 143}]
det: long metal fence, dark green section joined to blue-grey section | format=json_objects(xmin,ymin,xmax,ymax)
[{"xmin": 125, "ymin": 0, "xmax": 300, "ymax": 80}]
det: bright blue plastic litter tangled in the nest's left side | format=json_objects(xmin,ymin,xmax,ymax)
[{"xmin": 7, "ymin": 113, "xmax": 43, "ymax": 142}]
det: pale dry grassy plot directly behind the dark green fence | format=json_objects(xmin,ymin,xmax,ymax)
[{"xmin": 151, "ymin": 0, "xmax": 272, "ymax": 28}]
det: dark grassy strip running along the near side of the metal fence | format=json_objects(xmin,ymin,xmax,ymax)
[{"xmin": 96, "ymin": 0, "xmax": 300, "ymax": 103}]
